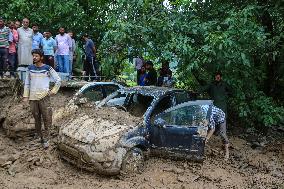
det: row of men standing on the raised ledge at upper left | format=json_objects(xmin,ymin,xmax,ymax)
[{"xmin": 0, "ymin": 18, "xmax": 98, "ymax": 78}]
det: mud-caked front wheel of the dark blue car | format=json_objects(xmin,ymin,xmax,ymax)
[{"xmin": 121, "ymin": 147, "xmax": 145, "ymax": 174}]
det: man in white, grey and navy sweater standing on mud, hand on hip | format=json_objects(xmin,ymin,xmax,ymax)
[{"xmin": 23, "ymin": 49, "xmax": 61, "ymax": 149}]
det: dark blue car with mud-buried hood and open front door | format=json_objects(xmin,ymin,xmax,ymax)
[{"xmin": 58, "ymin": 87, "xmax": 209, "ymax": 174}]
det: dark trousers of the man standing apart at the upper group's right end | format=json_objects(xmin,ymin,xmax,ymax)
[{"xmin": 84, "ymin": 57, "xmax": 99, "ymax": 81}]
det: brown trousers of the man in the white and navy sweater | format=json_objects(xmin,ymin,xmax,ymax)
[{"xmin": 30, "ymin": 96, "xmax": 52, "ymax": 140}]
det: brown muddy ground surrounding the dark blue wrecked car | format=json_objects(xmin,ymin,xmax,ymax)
[{"xmin": 0, "ymin": 79, "xmax": 284, "ymax": 189}]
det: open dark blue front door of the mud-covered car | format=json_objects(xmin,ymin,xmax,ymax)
[{"xmin": 150, "ymin": 100, "xmax": 212, "ymax": 161}]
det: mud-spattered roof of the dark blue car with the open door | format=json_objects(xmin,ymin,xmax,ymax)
[{"xmin": 119, "ymin": 86, "xmax": 185, "ymax": 97}]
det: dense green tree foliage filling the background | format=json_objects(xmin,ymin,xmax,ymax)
[{"xmin": 0, "ymin": 0, "xmax": 284, "ymax": 126}]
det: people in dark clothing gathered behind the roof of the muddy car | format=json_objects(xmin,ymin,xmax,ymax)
[{"xmin": 135, "ymin": 57, "xmax": 172, "ymax": 86}]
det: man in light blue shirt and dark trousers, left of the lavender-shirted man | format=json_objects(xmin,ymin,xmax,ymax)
[{"xmin": 41, "ymin": 31, "xmax": 57, "ymax": 69}]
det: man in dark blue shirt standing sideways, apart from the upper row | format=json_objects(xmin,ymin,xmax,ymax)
[{"xmin": 83, "ymin": 34, "xmax": 99, "ymax": 81}]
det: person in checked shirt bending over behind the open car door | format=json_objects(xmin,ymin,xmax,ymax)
[{"xmin": 206, "ymin": 105, "xmax": 229, "ymax": 160}]
